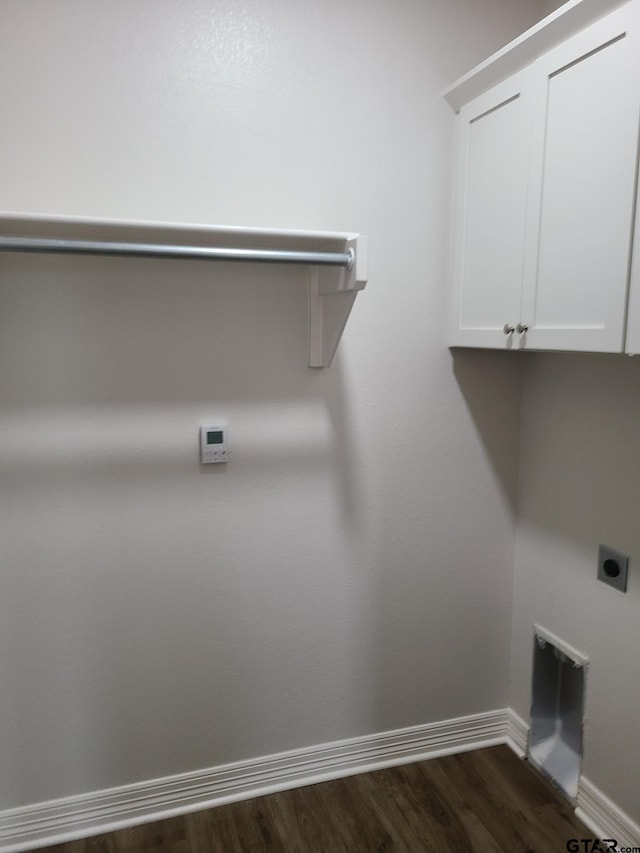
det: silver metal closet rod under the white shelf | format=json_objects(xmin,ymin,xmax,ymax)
[{"xmin": 0, "ymin": 236, "xmax": 355, "ymax": 268}]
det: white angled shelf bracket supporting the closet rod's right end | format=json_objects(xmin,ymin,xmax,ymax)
[{"xmin": 309, "ymin": 235, "xmax": 367, "ymax": 367}]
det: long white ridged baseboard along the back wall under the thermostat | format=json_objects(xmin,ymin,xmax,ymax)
[{"xmin": 0, "ymin": 710, "xmax": 509, "ymax": 853}]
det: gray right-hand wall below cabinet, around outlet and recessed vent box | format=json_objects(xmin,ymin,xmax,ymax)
[{"xmin": 511, "ymin": 354, "xmax": 640, "ymax": 820}]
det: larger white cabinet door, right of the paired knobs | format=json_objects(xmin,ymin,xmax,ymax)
[{"xmin": 521, "ymin": 2, "xmax": 640, "ymax": 352}]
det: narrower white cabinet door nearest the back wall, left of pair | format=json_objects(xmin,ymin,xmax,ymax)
[{"xmin": 449, "ymin": 69, "xmax": 531, "ymax": 348}]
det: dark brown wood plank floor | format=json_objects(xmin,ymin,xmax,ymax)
[{"xmin": 33, "ymin": 746, "xmax": 592, "ymax": 853}]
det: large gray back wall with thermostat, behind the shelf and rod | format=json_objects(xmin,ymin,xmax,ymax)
[{"xmin": 0, "ymin": 0, "xmax": 536, "ymax": 807}]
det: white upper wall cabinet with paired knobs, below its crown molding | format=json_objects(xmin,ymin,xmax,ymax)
[{"xmin": 449, "ymin": 0, "xmax": 640, "ymax": 352}]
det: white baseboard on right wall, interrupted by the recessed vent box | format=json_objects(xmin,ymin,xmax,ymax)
[{"xmin": 506, "ymin": 708, "xmax": 640, "ymax": 847}]
